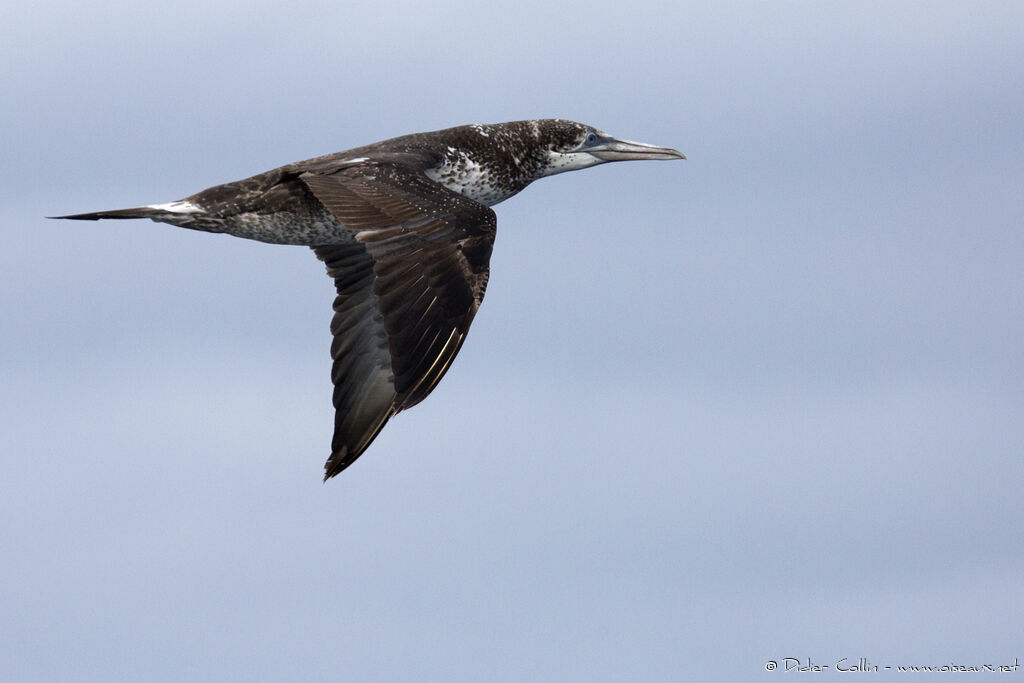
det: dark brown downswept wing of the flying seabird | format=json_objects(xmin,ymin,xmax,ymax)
[{"xmin": 299, "ymin": 163, "xmax": 497, "ymax": 479}]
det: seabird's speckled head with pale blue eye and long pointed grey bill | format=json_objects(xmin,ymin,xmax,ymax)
[{"xmin": 537, "ymin": 119, "xmax": 686, "ymax": 176}]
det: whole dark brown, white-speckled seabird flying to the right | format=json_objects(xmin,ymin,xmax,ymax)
[{"xmin": 55, "ymin": 119, "xmax": 685, "ymax": 481}]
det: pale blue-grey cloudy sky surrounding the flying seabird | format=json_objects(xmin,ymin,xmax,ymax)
[{"xmin": 0, "ymin": 0, "xmax": 1024, "ymax": 681}]
